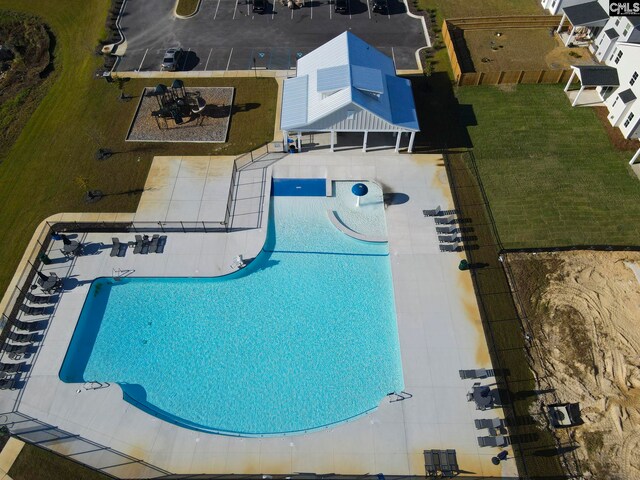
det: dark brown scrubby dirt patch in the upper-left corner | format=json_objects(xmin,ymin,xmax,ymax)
[{"xmin": 0, "ymin": 10, "xmax": 52, "ymax": 160}]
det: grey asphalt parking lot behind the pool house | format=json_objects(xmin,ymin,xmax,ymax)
[{"xmin": 117, "ymin": 0, "xmax": 427, "ymax": 71}]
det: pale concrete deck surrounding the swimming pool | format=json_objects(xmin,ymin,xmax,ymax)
[{"xmin": 0, "ymin": 150, "xmax": 517, "ymax": 478}]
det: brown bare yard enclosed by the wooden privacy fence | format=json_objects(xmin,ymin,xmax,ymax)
[{"xmin": 464, "ymin": 28, "xmax": 594, "ymax": 72}]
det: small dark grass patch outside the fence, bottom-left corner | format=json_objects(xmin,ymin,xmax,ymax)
[{"xmin": 9, "ymin": 444, "xmax": 111, "ymax": 480}]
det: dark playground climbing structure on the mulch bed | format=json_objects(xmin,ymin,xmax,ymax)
[{"xmin": 151, "ymin": 79, "xmax": 207, "ymax": 130}]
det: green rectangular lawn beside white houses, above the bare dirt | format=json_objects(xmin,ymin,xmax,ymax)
[{"xmin": 456, "ymin": 85, "xmax": 640, "ymax": 248}]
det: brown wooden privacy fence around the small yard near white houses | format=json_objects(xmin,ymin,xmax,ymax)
[{"xmin": 442, "ymin": 15, "xmax": 571, "ymax": 86}]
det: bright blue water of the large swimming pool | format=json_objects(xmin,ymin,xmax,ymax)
[{"xmin": 60, "ymin": 182, "xmax": 404, "ymax": 436}]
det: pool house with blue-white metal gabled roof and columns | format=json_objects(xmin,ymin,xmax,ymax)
[{"xmin": 280, "ymin": 32, "xmax": 420, "ymax": 152}]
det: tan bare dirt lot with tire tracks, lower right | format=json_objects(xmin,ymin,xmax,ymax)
[{"xmin": 505, "ymin": 251, "xmax": 640, "ymax": 480}]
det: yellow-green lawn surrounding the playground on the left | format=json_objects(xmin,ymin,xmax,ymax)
[{"xmin": 0, "ymin": 0, "xmax": 277, "ymax": 292}]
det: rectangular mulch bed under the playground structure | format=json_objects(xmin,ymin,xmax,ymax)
[{"xmin": 127, "ymin": 87, "xmax": 234, "ymax": 143}]
